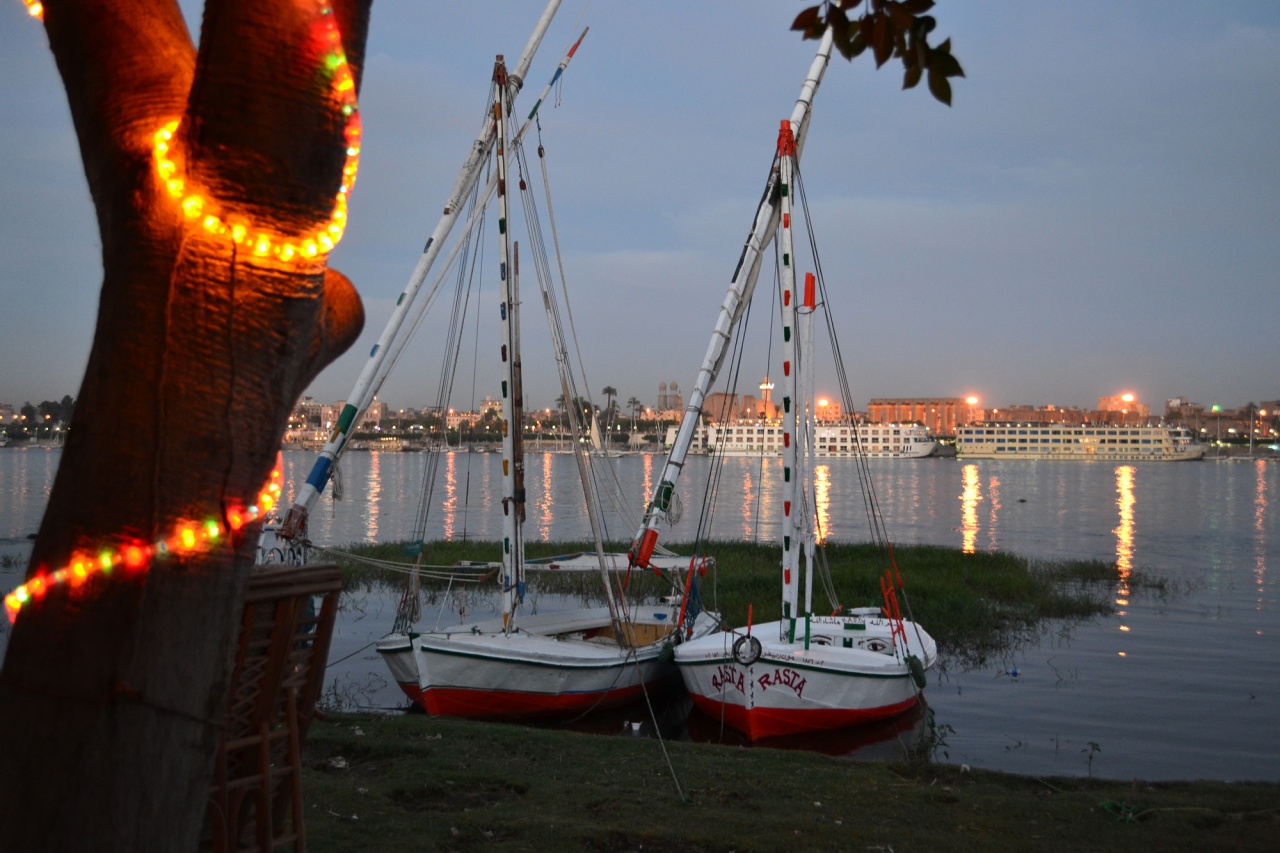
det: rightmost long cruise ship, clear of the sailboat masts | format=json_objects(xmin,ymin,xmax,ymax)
[{"xmin": 956, "ymin": 423, "xmax": 1204, "ymax": 462}]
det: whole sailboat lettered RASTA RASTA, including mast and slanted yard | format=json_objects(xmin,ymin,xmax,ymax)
[{"xmin": 634, "ymin": 35, "xmax": 937, "ymax": 740}]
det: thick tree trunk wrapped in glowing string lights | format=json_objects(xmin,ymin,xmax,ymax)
[{"xmin": 0, "ymin": 0, "xmax": 371, "ymax": 850}]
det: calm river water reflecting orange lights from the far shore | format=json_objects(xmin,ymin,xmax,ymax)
[{"xmin": 0, "ymin": 448, "xmax": 1280, "ymax": 780}]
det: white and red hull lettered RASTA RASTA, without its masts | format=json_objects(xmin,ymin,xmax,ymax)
[{"xmin": 676, "ymin": 616, "xmax": 937, "ymax": 740}]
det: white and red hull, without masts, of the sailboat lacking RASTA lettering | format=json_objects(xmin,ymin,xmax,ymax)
[{"xmin": 378, "ymin": 606, "xmax": 716, "ymax": 720}]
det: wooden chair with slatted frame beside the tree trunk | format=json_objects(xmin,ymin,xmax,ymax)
[{"xmin": 202, "ymin": 565, "xmax": 342, "ymax": 853}]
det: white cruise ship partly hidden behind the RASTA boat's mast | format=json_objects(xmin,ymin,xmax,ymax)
[{"xmin": 667, "ymin": 420, "xmax": 938, "ymax": 459}]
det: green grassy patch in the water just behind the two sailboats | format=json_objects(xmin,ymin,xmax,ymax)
[{"xmin": 325, "ymin": 542, "xmax": 1136, "ymax": 665}]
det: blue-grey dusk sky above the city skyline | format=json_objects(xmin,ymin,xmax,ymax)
[{"xmin": 0, "ymin": 0, "xmax": 1280, "ymax": 411}]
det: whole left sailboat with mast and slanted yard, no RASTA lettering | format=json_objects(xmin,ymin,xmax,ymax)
[{"xmin": 260, "ymin": 0, "xmax": 717, "ymax": 719}]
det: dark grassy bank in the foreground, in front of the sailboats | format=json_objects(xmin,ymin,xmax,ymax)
[{"xmin": 303, "ymin": 715, "xmax": 1280, "ymax": 853}]
